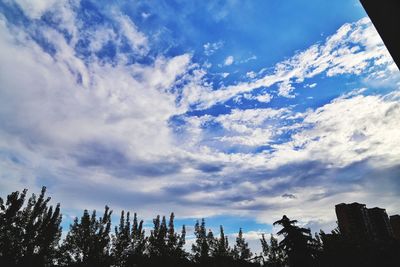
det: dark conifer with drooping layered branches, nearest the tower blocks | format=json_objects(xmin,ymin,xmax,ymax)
[{"xmin": 274, "ymin": 215, "xmax": 312, "ymax": 267}]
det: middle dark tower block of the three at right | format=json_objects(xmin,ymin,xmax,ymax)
[{"xmin": 368, "ymin": 207, "xmax": 393, "ymax": 241}]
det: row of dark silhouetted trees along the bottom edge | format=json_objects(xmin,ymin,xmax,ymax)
[{"xmin": 0, "ymin": 187, "xmax": 400, "ymax": 267}]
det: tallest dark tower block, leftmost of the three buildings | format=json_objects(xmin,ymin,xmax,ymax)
[{"xmin": 335, "ymin": 202, "xmax": 372, "ymax": 242}]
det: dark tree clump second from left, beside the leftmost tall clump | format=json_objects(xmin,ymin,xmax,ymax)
[{"xmin": 59, "ymin": 206, "xmax": 112, "ymax": 267}]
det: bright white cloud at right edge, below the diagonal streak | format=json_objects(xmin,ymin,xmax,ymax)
[{"xmin": 271, "ymin": 91, "xmax": 400, "ymax": 167}]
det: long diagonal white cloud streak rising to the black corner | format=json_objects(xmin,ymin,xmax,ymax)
[{"xmin": 180, "ymin": 18, "xmax": 400, "ymax": 109}]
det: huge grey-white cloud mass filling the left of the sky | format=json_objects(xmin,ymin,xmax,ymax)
[{"xmin": 0, "ymin": 12, "xmax": 194, "ymax": 207}]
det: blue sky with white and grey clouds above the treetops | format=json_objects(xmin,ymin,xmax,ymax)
[{"xmin": 0, "ymin": 0, "xmax": 400, "ymax": 254}]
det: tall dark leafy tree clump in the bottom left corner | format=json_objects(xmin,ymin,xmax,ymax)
[{"xmin": 0, "ymin": 187, "xmax": 61, "ymax": 266}]
